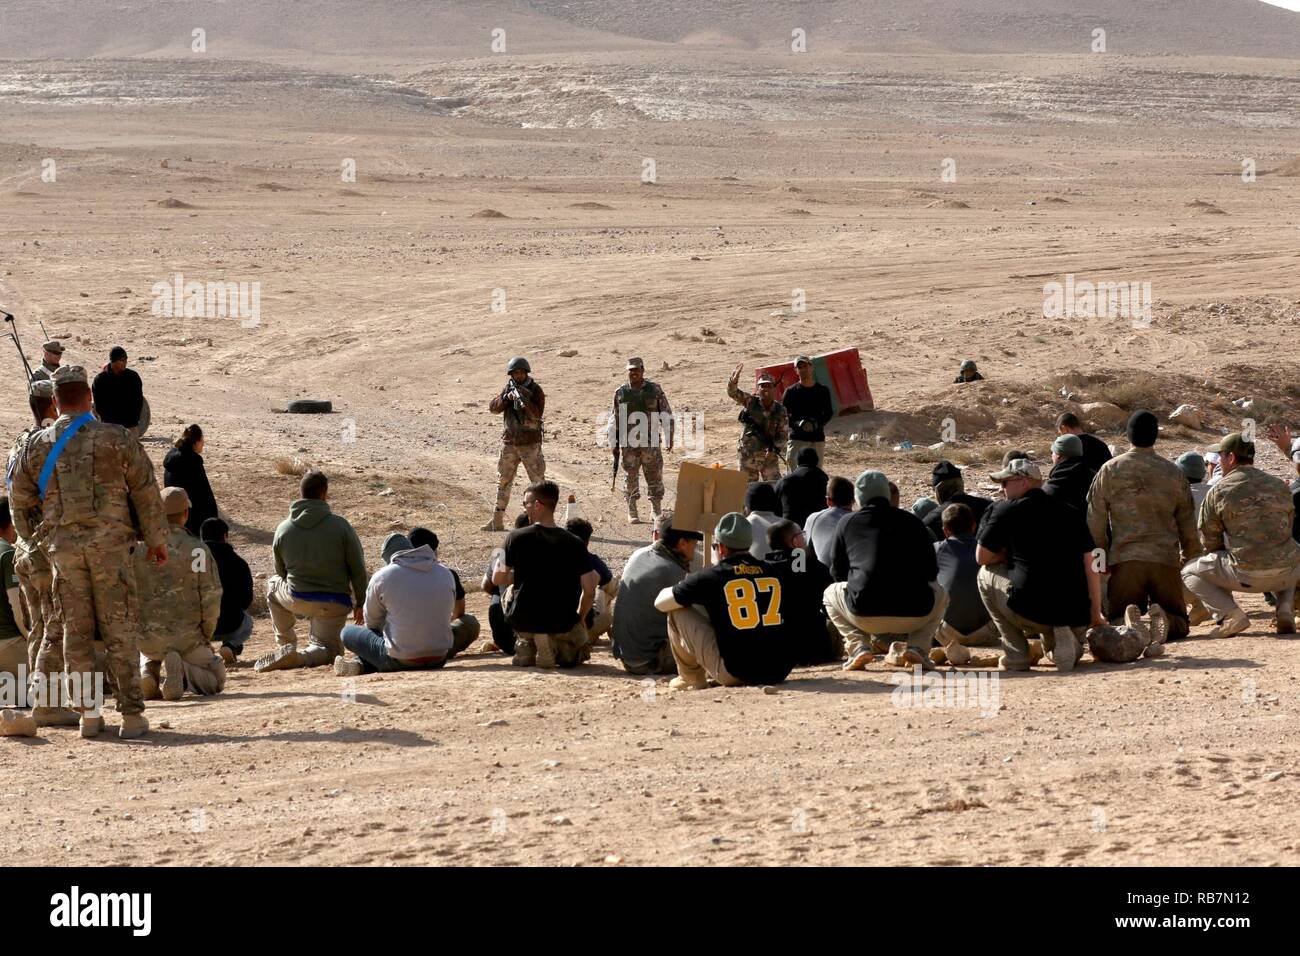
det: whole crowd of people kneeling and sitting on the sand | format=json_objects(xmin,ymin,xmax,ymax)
[{"xmin": 0, "ymin": 411, "xmax": 1300, "ymax": 700}]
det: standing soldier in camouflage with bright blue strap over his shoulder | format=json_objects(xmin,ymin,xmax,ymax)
[{"xmin": 10, "ymin": 365, "xmax": 166, "ymax": 737}]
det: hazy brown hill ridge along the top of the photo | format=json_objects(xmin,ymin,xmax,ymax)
[{"xmin": 0, "ymin": 0, "xmax": 1300, "ymax": 60}]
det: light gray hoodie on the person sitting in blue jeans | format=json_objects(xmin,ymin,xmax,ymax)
[{"xmin": 365, "ymin": 545, "xmax": 456, "ymax": 661}]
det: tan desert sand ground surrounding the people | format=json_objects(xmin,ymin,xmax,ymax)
[{"xmin": 0, "ymin": 0, "xmax": 1300, "ymax": 865}]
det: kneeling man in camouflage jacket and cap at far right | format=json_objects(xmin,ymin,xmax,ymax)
[{"xmin": 1183, "ymin": 432, "xmax": 1300, "ymax": 637}]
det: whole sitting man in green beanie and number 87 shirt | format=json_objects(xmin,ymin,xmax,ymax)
[{"xmin": 655, "ymin": 511, "xmax": 794, "ymax": 691}]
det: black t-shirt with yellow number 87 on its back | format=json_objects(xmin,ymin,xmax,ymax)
[{"xmin": 672, "ymin": 551, "xmax": 794, "ymax": 684}]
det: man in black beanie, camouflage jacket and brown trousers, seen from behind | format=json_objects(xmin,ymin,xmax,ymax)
[{"xmin": 1088, "ymin": 411, "xmax": 1201, "ymax": 640}]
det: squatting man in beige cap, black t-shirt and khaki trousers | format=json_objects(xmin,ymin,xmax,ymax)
[{"xmin": 975, "ymin": 458, "xmax": 1106, "ymax": 671}]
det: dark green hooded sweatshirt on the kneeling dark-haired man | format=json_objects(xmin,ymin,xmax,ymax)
[{"xmin": 270, "ymin": 498, "xmax": 368, "ymax": 606}]
